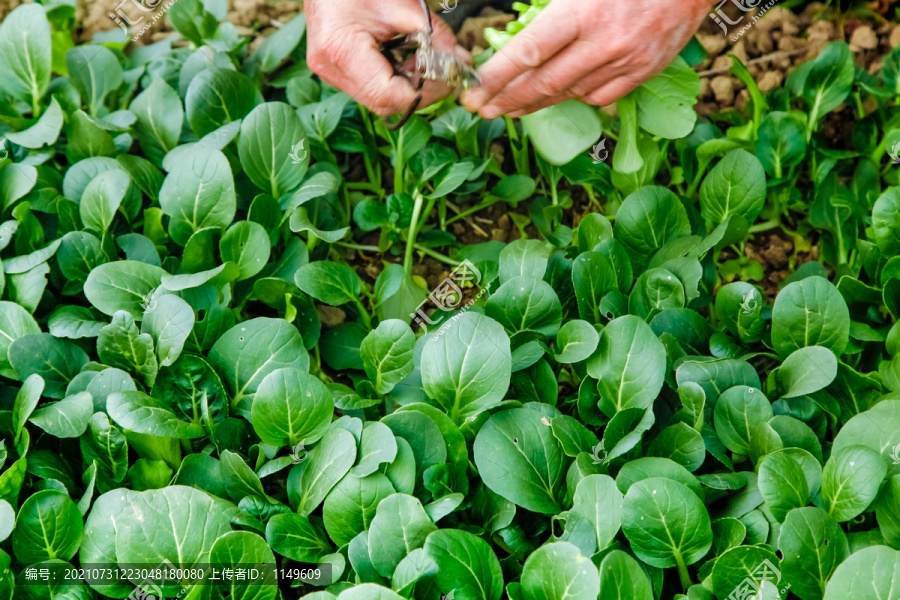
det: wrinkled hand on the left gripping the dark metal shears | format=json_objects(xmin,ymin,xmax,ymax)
[{"xmin": 304, "ymin": 0, "xmax": 469, "ymax": 116}]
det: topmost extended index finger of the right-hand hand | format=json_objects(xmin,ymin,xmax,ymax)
[{"xmin": 464, "ymin": 3, "xmax": 578, "ymax": 112}]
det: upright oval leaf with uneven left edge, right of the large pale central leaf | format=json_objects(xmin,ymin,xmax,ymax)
[{"xmin": 587, "ymin": 315, "xmax": 666, "ymax": 417}]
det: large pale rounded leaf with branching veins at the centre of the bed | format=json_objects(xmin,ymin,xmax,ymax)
[{"xmin": 421, "ymin": 312, "xmax": 512, "ymax": 423}]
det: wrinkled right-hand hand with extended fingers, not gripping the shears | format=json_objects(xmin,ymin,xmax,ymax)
[{"xmin": 463, "ymin": 0, "xmax": 711, "ymax": 119}]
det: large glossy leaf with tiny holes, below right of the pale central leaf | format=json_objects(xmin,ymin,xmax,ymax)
[{"xmin": 473, "ymin": 408, "xmax": 569, "ymax": 514}]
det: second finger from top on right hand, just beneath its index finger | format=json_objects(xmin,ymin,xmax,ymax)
[{"xmin": 482, "ymin": 40, "xmax": 603, "ymax": 118}]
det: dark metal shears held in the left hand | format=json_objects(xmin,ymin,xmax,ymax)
[{"xmin": 381, "ymin": 0, "xmax": 481, "ymax": 129}]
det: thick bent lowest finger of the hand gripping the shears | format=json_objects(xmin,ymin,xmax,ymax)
[{"xmin": 307, "ymin": 29, "xmax": 416, "ymax": 116}]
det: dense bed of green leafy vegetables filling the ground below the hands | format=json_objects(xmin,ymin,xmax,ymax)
[{"xmin": 0, "ymin": 0, "xmax": 900, "ymax": 600}]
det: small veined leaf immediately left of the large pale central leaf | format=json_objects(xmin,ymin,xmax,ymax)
[{"xmin": 359, "ymin": 319, "xmax": 416, "ymax": 394}]
